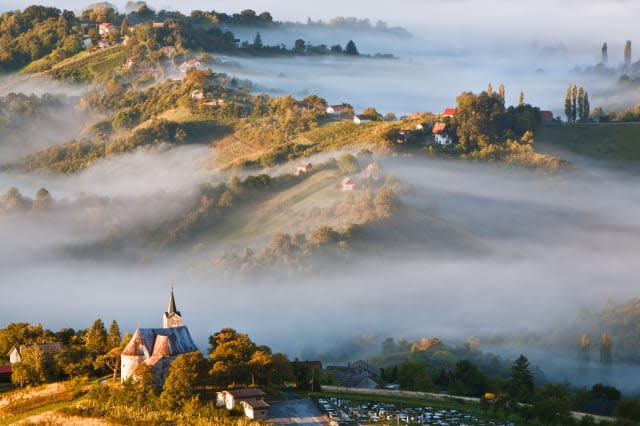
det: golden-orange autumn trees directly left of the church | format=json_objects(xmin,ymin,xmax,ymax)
[{"xmin": 0, "ymin": 319, "xmax": 127, "ymax": 386}]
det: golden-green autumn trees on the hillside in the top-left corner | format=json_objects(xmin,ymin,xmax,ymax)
[{"xmin": 0, "ymin": 6, "xmax": 82, "ymax": 72}]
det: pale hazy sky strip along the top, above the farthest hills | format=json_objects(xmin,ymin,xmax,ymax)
[{"xmin": 0, "ymin": 0, "xmax": 640, "ymax": 43}]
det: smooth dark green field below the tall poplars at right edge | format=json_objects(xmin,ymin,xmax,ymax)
[{"xmin": 536, "ymin": 123, "xmax": 640, "ymax": 165}]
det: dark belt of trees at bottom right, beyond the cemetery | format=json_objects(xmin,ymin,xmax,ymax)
[{"xmin": 376, "ymin": 336, "xmax": 640, "ymax": 424}]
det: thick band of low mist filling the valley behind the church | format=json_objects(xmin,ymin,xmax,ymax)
[{"xmin": 0, "ymin": 150, "xmax": 640, "ymax": 392}]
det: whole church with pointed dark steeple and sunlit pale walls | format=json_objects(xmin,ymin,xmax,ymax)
[{"xmin": 120, "ymin": 287, "xmax": 198, "ymax": 385}]
